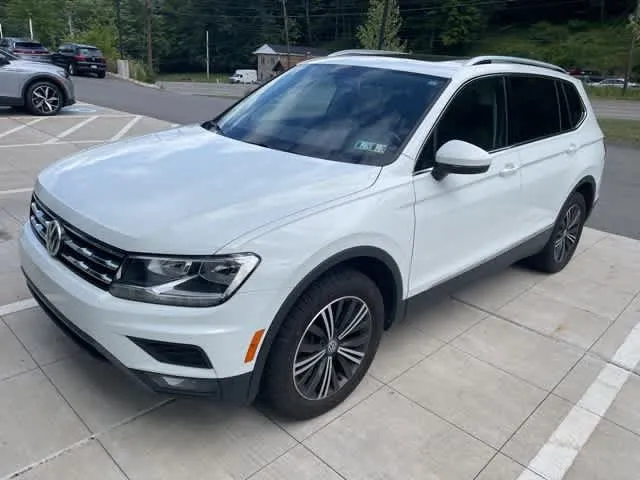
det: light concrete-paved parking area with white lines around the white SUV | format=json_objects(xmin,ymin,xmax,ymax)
[{"xmin": 0, "ymin": 105, "xmax": 640, "ymax": 480}]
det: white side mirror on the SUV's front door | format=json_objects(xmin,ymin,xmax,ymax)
[{"xmin": 431, "ymin": 140, "xmax": 491, "ymax": 181}]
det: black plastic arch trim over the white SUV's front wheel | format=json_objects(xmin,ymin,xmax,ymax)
[{"xmin": 248, "ymin": 246, "xmax": 404, "ymax": 401}]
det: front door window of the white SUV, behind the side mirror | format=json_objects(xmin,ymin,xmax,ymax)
[{"xmin": 416, "ymin": 77, "xmax": 507, "ymax": 171}]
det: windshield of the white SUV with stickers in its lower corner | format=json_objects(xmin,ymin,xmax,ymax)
[{"xmin": 216, "ymin": 64, "xmax": 448, "ymax": 165}]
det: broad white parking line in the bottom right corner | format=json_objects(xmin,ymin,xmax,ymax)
[{"xmin": 518, "ymin": 316, "xmax": 640, "ymax": 480}]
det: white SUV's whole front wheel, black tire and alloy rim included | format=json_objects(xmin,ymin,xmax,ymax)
[{"xmin": 263, "ymin": 269, "xmax": 384, "ymax": 419}]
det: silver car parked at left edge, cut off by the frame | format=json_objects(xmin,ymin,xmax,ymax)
[{"xmin": 0, "ymin": 50, "xmax": 76, "ymax": 116}]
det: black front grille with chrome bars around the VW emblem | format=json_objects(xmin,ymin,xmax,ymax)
[{"xmin": 29, "ymin": 195, "xmax": 125, "ymax": 290}]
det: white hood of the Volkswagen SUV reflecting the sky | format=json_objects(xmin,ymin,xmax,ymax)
[{"xmin": 35, "ymin": 126, "xmax": 380, "ymax": 255}]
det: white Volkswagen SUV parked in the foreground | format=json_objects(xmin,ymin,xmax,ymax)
[{"xmin": 21, "ymin": 52, "xmax": 605, "ymax": 418}]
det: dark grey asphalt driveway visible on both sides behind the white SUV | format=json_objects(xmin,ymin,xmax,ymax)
[{"xmin": 74, "ymin": 77, "xmax": 640, "ymax": 239}]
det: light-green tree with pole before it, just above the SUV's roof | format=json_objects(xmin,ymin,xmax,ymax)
[{"xmin": 356, "ymin": 0, "xmax": 406, "ymax": 51}]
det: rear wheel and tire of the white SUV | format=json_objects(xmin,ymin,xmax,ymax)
[{"xmin": 526, "ymin": 192, "xmax": 587, "ymax": 273}]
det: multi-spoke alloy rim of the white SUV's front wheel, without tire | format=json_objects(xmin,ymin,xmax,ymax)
[{"xmin": 293, "ymin": 297, "xmax": 372, "ymax": 400}]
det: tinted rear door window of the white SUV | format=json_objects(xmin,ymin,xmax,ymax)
[{"xmin": 508, "ymin": 76, "xmax": 560, "ymax": 145}]
